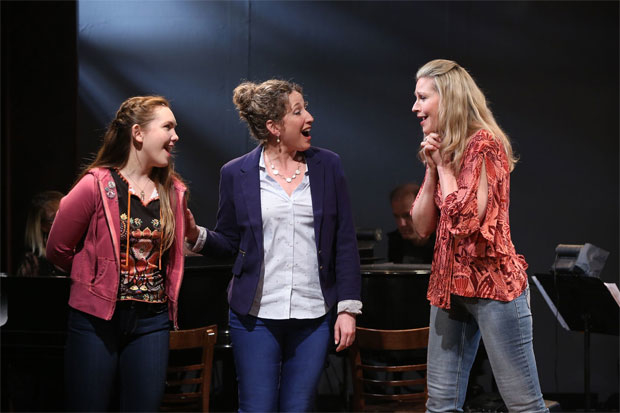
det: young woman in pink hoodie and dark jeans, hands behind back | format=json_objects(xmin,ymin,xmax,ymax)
[{"xmin": 47, "ymin": 96, "xmax": 197, "ymax": 411}]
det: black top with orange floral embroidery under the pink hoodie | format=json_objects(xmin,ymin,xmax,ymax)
[{"xmin": 112, "ymin": 170, "xmax": 167, "ymax": 303}]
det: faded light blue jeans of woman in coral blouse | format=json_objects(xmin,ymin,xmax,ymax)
[{"xmin": 426, "ymin": 288, "xmax": 547, "ymax": 413}]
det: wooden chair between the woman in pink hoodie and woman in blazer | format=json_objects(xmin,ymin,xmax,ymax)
[{"xmin": 160, "ymin": 325, "xmax": 217, "ymax": 412}]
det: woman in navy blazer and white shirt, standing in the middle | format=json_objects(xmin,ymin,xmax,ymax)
[{"xmin": 191, "ymin": 79, "xmax": 362, "ymax": 412}]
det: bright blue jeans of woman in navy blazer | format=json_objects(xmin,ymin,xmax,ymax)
[{"xmin": 230, "ymin": 311, "xmax": 332, "ymax": 412}]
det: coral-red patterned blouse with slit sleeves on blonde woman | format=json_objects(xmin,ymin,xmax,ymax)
[{"xmin": 418, "ymin": 129, "xmax": 527, "ymax": 308}]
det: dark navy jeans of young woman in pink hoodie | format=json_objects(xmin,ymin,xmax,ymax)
[{"xmin": 65, "ymin": 301, "xmax": 170, "ymax": 412}]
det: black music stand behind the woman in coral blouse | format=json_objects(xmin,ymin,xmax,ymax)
[{"xmin": 532, "ymin": 274, "xmax": 620, "ymax": 411}]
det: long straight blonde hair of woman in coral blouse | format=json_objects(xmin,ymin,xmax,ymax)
[{"xmin": 416, "ymin": 59, "xmax": 517, "ymax": 172}]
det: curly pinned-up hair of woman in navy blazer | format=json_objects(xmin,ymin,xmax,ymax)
[{"xmin": 233, "ymin": 79, "xmax": 303, "ymax": 144}]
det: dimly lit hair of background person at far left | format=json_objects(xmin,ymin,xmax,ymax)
[{"xmin": 24, "ymin": 191, "xmax": 64, "ymax": 258}]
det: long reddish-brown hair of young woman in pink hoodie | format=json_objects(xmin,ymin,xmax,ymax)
[{"xmin": 76, "ymin": 96, "xmax": 187, "ymax": 251}]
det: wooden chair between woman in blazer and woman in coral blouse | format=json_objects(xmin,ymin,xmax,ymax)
[{"xmin": 349, "ymin": 327, "xmax": 429, "ymax": 412}]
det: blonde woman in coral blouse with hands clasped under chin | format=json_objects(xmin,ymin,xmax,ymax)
[{"xmin": 411, "ymin": 60, "xmax": 547, "ymax": 412}]
